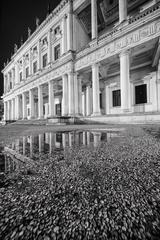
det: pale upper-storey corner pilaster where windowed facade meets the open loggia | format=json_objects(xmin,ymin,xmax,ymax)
[{"xmin": 67, "ymin": 1, "xmax": 73, "ymax": 51}]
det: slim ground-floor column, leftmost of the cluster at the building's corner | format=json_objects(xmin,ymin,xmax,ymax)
[{"xmin": 62, "ymin": 74, "xmax": 68, "ymax": 116}]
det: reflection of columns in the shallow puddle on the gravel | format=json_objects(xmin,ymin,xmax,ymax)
[{"xmin": 0, "ymin": 131, "xmax": 120, "ymax": 173}]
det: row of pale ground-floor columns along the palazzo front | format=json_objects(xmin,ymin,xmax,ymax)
[{"xmin": 4, "ymin": 51, "xmax": 131, "ymax": 120}]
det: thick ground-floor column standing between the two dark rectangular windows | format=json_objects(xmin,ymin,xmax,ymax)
[{"xmin": 120, "ymin": 51, "xmax": 131, "ymax": 112}]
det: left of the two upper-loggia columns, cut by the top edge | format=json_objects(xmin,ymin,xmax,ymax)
[{"xmin": 91, "ymin": 0, "xmax": 98, "ymax": 40}]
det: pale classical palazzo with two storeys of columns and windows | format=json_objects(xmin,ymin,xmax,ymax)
[{"xmin": 2, "ymin": 0, "xmax": 160, "ymax": 122}]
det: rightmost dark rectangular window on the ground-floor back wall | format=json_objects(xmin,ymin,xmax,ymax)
[{"xmin": 135, "ymin": 84, "xmax": 147, "ymax": 104}]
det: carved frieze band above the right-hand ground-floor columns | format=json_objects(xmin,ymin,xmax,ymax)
[{"xmin": 75, "ymin": 21, "xmax": 160, "ymax": 71}]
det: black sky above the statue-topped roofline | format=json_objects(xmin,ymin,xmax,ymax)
[{"xmin": 0, "ymin": 0, "xmax": 61, "ymax": 96}]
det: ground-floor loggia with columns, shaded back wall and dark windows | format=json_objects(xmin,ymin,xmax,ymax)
[{"xmin": 4, "ymin": 39, "xmax": 160, "ymax": 124}]
